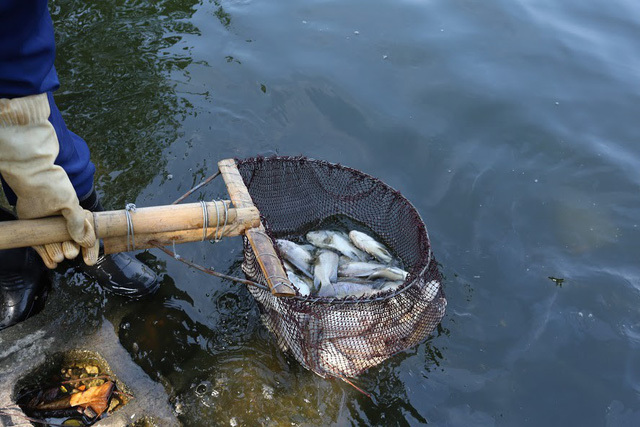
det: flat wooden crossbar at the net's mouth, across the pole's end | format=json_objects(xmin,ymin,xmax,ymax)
[{"xmin": 218, "ymin": 159, "xmax": 296, "ymax": 297}]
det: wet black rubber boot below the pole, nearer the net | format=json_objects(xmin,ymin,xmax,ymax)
[{"xmin": 80, "ymin": 190, "xmax": 159, "ymax": 298}]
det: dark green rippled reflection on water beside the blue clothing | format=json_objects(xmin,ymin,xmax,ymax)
[{"xmin": 51, "ymin": 0, "xmax": 198, "ymax": 207}]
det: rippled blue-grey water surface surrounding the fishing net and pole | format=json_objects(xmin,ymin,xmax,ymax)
[{"xmin": 51, "ymin": 0, "xmax": 640, "ymax": 426}]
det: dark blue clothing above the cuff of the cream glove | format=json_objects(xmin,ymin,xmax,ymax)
[{"xmin": 0, "ymin": 0, "xmax": 60, "ymax": 98}]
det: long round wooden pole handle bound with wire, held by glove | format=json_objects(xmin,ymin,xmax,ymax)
[{"xmin": 0, "ymin": 200, "xmax": 260, "ymax": 253}]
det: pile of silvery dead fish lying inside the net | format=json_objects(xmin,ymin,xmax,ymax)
[{"xmin": 276, "ymin": 230, "xmax": 408, "ymax": 298}]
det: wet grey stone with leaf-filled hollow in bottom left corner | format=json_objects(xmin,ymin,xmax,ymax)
[{"xmin": 0, "ymin": 316, "xmax": 179, "ymax": 427}]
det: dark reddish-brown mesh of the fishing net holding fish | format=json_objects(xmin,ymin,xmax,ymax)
[{"xmin": 238, "ymin": 157, "xmax": 447, "ymax": 378}]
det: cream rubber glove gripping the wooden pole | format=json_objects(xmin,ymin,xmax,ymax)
[{"xmin": 0, "ymin": 94, "xmax": 98, "ymax": 268}]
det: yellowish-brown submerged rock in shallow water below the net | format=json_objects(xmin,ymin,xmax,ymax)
[{"xmin": 174, "ymin": 347, "xmax": 351, "ymax": 425}]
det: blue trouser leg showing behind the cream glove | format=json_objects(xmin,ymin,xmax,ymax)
[{"xmin": 2, "ymin": 92, "xmax": 96, "ymax": 205}]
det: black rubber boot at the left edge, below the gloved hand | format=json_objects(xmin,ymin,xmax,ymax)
[{"xmin": 0, "ymin": 208, "xmax": 51, "ymax": 330}]
